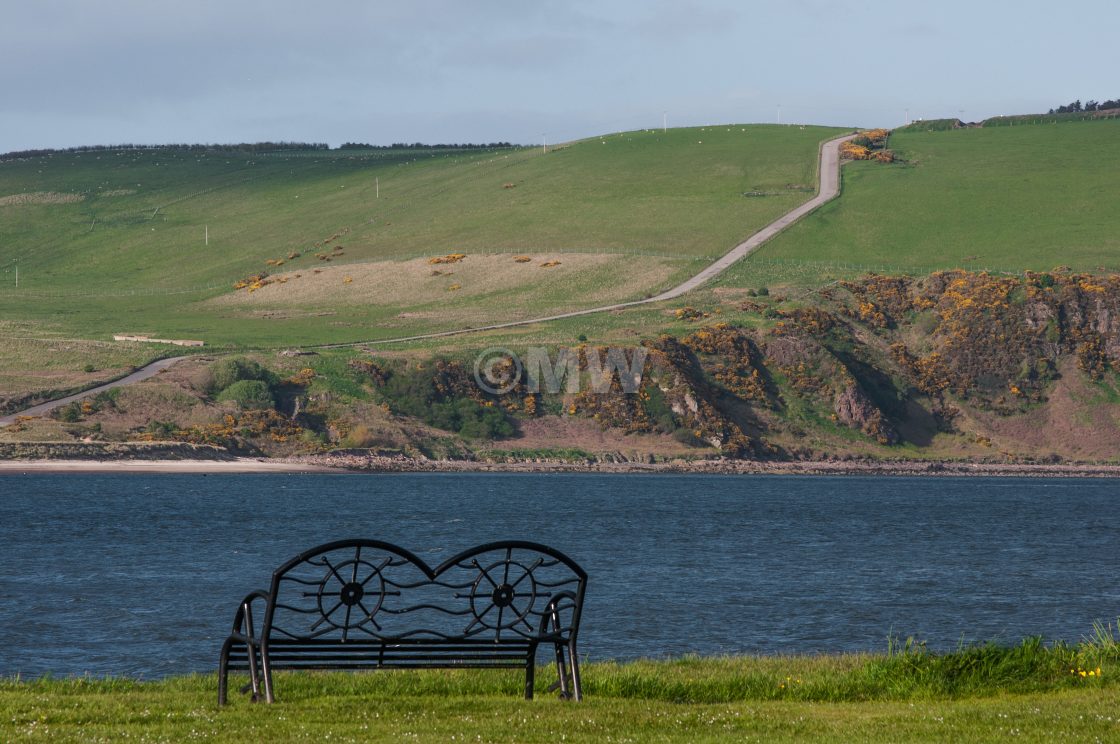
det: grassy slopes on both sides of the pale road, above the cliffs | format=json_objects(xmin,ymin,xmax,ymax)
[{"xmin": 0, "ymin": 120, "xmax": 1120, "ymax": 407}]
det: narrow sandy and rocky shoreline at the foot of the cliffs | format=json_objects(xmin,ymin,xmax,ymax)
[{"xmin": 0, "ymin": 454, "xmax": 1120, "ymax": 478}]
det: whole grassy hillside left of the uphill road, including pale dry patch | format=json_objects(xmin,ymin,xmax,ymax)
[{"xmin": 0, "ymin": 125, "xmax": 840, "ymax": 345}]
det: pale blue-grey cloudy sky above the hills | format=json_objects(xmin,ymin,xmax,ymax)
[{"xmin": 0, "ymin": 0, "xmax": 1120, "ymax": 151}]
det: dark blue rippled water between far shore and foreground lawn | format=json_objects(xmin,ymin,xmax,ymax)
[{"xmin": 0, "ymin": 473, "xmax": 1120, "ymax": 678}]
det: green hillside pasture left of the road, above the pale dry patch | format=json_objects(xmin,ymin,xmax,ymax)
[{"xmin": 0, "ymin": 125, "xmax": 840, "ymax": 292}]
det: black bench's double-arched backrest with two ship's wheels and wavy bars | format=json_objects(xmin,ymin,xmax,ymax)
[{"xmin": 261, "ymin": 539, "xmax": 587, "ymax": 642}]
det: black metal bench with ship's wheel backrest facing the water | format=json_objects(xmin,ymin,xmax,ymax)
[{"xmin": 217, "ymin": 540, "xmax": 587, "ymax": 705}]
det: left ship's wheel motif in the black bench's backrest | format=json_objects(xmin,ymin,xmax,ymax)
[{"xmin": 311, "ymin": 547, "xmax": 388, "ymax": 635}]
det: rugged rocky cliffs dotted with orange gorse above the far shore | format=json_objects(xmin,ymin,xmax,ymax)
[{"xmin": 50, "ymin": 271, "xmax": 1120, "ymax": 464}]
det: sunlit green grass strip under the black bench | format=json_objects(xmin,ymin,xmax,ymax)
[{"xmin": 0, "ymin": 641, "xmax": 1120, "ymax": 742}]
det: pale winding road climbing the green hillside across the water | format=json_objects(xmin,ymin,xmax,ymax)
[{"xmin": 0, "ymin": 133, "xmax": 858, "ymax": 427}]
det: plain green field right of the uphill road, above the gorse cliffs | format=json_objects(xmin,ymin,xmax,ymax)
[{"xmin": 743, "ymin": 119, "xmax": 1120, "ymax": 273}]
